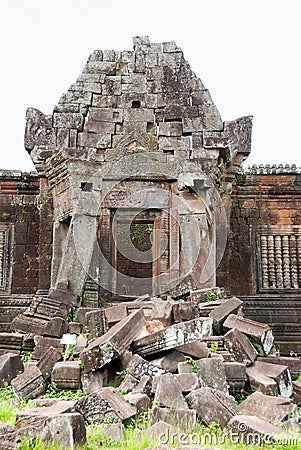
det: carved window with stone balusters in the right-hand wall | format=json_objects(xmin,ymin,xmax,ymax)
[{"xmin": 255, "ymin": 225, "xmax": 301, "ymax": 293}]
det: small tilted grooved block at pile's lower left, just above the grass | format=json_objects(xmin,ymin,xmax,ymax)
[{"xmin": 11, "ymin": 365, "xmax": 46, "ymax": 400}]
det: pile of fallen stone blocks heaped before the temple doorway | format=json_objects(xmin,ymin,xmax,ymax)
[{"xmin": 0, "ymin": 289, "xmax": 301, "ymax": 449}]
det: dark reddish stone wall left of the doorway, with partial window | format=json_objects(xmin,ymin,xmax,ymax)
[{"xmin": 0, "ymin": 170, "xmax": 52, "ymax": 330}]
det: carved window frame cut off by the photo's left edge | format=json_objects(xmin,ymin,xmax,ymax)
[{"xmin": 0, "ymin": 223, "xmax": 13, "ymax": 295}]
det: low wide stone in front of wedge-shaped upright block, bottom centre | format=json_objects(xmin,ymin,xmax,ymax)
[{"xmin": 149, "ymin": 406, "xmax": 196, "ymax": 433}]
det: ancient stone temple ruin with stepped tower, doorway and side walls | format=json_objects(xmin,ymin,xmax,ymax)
[{"xmin": 0, "ymin": 37, "xmax": 301, "ymax": 354}]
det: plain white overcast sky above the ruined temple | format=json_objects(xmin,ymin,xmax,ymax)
[{"xmin": 0, "ymin": 0, "xmax": 301, "ymax": 171}]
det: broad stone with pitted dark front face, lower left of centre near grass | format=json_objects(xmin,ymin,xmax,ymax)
[{"xmin": 75, "ymin": 387, "xmax": 137, "ymax": 424}]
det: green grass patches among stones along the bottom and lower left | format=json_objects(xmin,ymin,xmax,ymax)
[{"xmin": 0, "ymin": 387, "xmax": 301, "ymax": 450}]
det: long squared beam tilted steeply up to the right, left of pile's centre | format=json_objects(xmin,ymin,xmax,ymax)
[{"xmin": 80, "ymin": 309, "xmax": 145, "ymax": 372}]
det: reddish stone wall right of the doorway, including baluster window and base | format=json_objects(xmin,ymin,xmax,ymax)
[{"xmin": 217, "ymin": 166, "xmax": 301, "ymax": 350}]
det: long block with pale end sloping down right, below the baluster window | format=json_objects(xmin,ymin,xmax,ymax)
[{"xmin": 224, "ymin": 314, "xmax": 274, "ymax": 356}]
